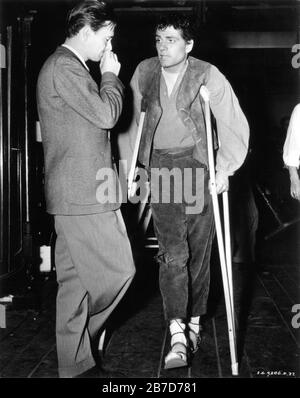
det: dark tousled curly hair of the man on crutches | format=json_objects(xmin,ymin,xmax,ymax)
[{"xmin": 155, "ymin": 14, "xmax": 195, "ymax": 41}]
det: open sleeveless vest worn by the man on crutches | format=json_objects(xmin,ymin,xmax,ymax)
[{"xmin": 138, "ymin": 57, "xmax": 210, "ymax": 167}]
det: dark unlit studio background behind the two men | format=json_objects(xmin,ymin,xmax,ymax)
[{"xmin": 1, "ymin": 0, "xmax": 300, "ymax": 290}]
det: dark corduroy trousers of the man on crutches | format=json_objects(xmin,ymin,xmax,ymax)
[{"xmin": 151, "ymin": 148, "xmax": 214, "ymax": 321}]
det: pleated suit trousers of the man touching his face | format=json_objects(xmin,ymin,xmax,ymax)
[{"xmin": 55, "ymin": 210, "xmax": 135, "ymax": 377}]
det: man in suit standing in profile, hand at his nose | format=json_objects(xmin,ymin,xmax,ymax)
[{"xmin": 37, "ymin": 0, "xmax": 135, "ymax": 377}]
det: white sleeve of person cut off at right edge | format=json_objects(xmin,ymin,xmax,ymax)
[{"xmin": 283, "ymin": 104, "xmax": 300, "ymax": 168}]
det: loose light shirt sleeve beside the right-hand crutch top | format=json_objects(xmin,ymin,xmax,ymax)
[{"xmin": 207, "ymin": 65, "xmax": 249, "ymax": 176}]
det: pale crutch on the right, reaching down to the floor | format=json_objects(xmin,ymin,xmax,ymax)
[{"xmin": 200, "ymin": 86, "xmax": 238, "ymax": 376}]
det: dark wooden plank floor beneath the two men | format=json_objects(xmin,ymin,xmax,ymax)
[{"xmin": 0, "ymin": 222, "xmax": 300, "ymax": 379}]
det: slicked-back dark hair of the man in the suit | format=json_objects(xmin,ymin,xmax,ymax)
[{"xmin": 66, "ymin": 0, "xmax": 116, "ymax": 38}]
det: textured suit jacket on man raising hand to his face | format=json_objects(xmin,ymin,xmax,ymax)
[{"xmin": 37, "ymin": 46, "xmax": 124, "ymax": 215}]
